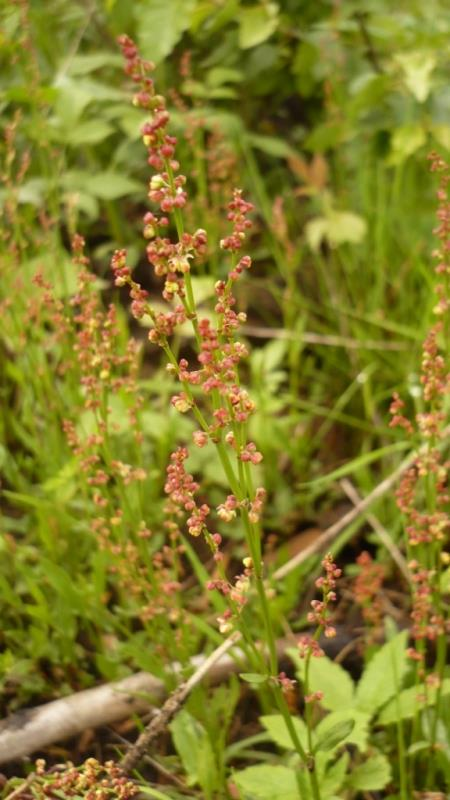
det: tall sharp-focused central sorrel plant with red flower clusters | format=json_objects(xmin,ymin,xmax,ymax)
[{"xmin": 112, "ymin": 36, "xmax": 340, "ymax": 800}]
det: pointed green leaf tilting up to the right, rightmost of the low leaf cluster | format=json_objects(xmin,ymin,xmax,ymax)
[{"xmin": 356, "ymin": 631, "xmax": 408, "ymax": 714}]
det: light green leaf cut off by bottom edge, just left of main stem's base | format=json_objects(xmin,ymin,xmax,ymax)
[{"xmin": 232, "ymin": 764, "xmax": 298, "ymax": 800}]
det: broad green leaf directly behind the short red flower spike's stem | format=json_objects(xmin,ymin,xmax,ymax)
[{"xmin": 289, "ymin": 649, "xmax": 355, "ymax": 711}]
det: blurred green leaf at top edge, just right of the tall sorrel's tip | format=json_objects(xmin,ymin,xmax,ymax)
[{"xmin": 134, "ymin": 0, "xmax": 195, "ymax": 64}]
